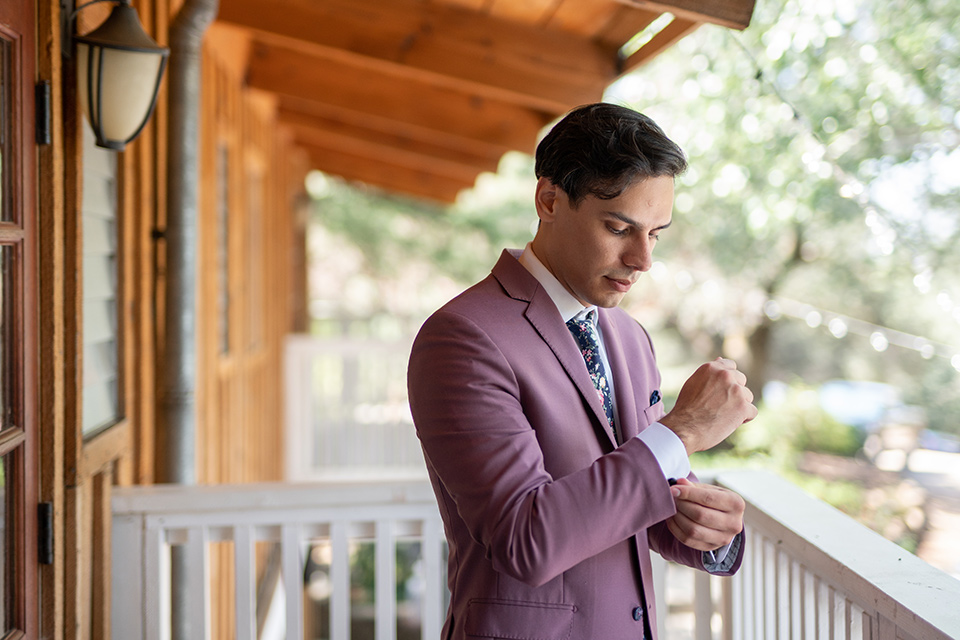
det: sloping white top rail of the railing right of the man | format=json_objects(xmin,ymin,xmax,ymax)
[{"xmin": 716, "ymin": 470, "xmax": 960, "ymax": 638}]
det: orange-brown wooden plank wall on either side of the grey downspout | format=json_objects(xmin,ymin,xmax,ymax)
[{"xmin": 37, "ymin": 0, "xmax": 306, "ymax": 640}]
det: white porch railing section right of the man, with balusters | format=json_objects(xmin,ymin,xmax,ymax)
[{"xmin": 666, "ymin": 471, "xmax": 960, "ymax": 640}]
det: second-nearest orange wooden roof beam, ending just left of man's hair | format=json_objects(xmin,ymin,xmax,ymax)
[{"xmin": 247, "ymin": 43, "xmax": 551, "ymax": 150}]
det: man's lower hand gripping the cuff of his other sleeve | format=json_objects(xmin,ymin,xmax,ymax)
[{"xmin": 667, "ymin": 478, "xmax": 745, "ymax": 551}]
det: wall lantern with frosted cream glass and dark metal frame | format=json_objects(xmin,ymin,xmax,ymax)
[{"xmin": 61, "ymin": 0, "xmax": 170, "ymax": 151}]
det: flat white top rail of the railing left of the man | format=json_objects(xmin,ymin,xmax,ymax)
[{"xmin": 111, "ymin": 480, "xmax": 436, "ymax": 516}]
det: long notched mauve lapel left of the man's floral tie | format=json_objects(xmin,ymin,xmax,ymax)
[{"xmin": 493, "ymin": 251, "xmax": 620, "ymax": 448}]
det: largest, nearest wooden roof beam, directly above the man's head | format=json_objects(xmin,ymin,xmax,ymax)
[{"xmin": 217, "ymin": 0, "xmax": 617, "ymax": 115}]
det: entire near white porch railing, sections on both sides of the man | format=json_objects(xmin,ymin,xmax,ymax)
[{"xmin": 112, "ymin": 471, "xmax": 960, "ymax": 640}]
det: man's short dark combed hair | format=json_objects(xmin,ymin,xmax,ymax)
[{"xmin": 535, "ymin": 102, "xmax": 687, "ymax": 206}]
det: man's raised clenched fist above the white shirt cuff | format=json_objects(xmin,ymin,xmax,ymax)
[{"xmin": 660, "ymin": 358, "xmax": 757, "ymax": 455}]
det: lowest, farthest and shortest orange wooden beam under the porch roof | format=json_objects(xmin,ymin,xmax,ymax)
[{"xmin": 303, "ymin": 144, "xmax": 473, "ymax": 203}]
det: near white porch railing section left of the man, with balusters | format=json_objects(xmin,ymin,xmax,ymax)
[{"xmin": 112, "ymin": 481, "xmax": 445, "ymax": 640}]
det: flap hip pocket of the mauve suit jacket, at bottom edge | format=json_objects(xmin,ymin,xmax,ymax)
[{"xmin": 465, "ymin": 600, "xmax": 577, "ymax": 640}]
